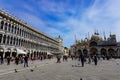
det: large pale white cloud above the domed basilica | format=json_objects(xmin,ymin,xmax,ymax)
[{"xmin": 58, "ymin": 0, "xmax": 120, "ymax": 45}]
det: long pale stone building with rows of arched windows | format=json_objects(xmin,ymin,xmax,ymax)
[{"xmin": 0, "ymin": 10, "xmax": 62, "ymax": 58}]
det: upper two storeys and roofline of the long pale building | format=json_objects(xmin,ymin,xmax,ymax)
[{"xmin": 0, "ymin": 12, "xmax": 59, "ymax": 51}]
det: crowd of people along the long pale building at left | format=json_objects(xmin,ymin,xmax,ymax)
[{"xmin": 0, "ymin": 55, "xmax": 52, "ymax": 67}]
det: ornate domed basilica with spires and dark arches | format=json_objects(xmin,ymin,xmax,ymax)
[{"xmin": 71, "ymin": 32, "xmax": 120, "ymax": 57}]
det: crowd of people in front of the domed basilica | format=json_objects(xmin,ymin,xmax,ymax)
[{"xmin": 56, "ymin": 51, "xmax": 117, "ymax": 67}]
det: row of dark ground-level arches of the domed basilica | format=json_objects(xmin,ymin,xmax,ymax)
[{"xmin": 78, "ymin": 47, "xmax": 120, "ymax": 57}]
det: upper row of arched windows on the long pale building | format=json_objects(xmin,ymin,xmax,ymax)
[{"xmin": 0, "ymin": 21, "xmax": 58, "ymax": 46}]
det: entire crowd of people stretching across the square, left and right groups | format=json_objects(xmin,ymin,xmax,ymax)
[{"xmin": 0, "ymin": 52, "xmax": 116, "ymax": 67}]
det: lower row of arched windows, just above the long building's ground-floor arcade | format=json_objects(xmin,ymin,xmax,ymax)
[{"xmin": 0, "ymin": 34, "xmax": 58, "ymax": 50}]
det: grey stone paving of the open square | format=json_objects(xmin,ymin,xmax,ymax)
[{"xmin": 0, "ymin": 59, "xmax": 120, "ymax": 80}]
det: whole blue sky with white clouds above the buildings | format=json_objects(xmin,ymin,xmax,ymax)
[{"xmin": 0, "ymin": 0, "xmax": 120, "ymax": 47}]
